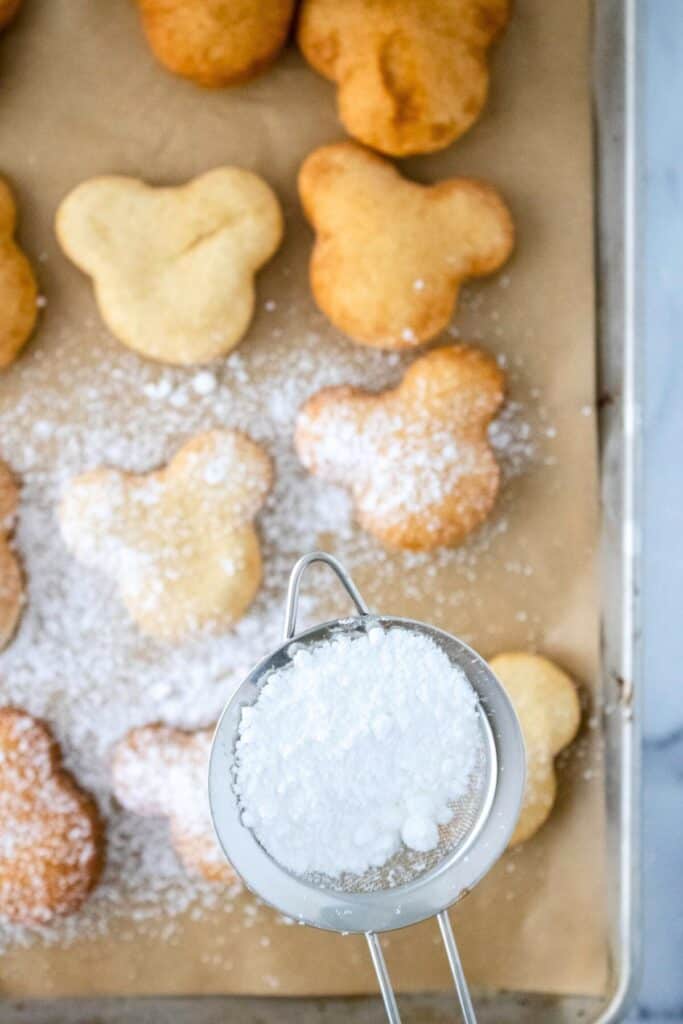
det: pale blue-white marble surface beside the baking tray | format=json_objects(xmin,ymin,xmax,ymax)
[{"xmin": 626, "ymin": 0, "xmax": 683, "ymax": 1024}]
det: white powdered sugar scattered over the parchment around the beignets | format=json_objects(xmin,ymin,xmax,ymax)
[{"xmin": 0, "ymin": 321, "xmax": 536, "ymax": 948}]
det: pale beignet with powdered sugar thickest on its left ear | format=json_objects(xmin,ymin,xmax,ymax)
[{"xmin": 59, "ymin": 430, "xmax": 272, "ymax": 643}]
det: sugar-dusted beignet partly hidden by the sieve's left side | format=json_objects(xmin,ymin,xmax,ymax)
[{"xmin": 112, "ymin": 724, "xmax": 237, "ymax": 885}]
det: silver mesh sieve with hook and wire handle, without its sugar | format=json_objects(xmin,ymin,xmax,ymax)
[{"xmin": 209, "ymin": 552, "xmax": 525, "ymax": 1024}]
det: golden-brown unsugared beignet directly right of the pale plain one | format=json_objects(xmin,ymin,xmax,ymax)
[{"xmin": 299, "ymin": 142, "xmax": 514, "ymax": 349}]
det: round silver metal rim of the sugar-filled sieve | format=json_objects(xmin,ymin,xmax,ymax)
[{"xmin": 209, "ymin": 613, "xmax": 525, "ymax": 934}]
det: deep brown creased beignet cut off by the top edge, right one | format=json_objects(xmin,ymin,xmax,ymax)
[{"xmin": 298, "ymin": 0, "xmax": 510, "ymax": 157}]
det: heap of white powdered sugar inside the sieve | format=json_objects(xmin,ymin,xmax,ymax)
[{"xmin": 234, "ymin": 626, "xmax": 483, "ymax": 879}]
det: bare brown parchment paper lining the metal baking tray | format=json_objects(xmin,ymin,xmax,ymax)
[{"xmin": 0, "ymin": 0, "xmax": 607, "ymax": 995}]
